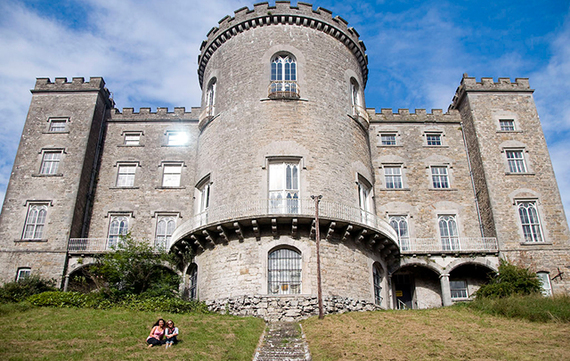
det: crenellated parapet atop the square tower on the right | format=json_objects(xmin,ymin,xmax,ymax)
[{"xmin": 449, "ymin": 73, "xmax": 534, "ymax": 109}]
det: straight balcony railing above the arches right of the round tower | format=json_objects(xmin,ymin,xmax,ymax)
[{"xmin": 399, "ymin": 237, "xmax": 499, "ymax": 254}]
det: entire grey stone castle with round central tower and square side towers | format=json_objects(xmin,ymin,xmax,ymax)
[{"xmin": 0, "ymin": 1, "xmax": 570, "ymax": 319}]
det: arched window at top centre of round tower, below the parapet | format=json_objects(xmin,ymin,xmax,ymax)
[{"xmin": 269, "ymin": 54, "xmax": 299, "ymax": 98}]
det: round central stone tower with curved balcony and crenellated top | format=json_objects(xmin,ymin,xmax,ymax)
[{"xmin": 173, "ymin": 2, "xmax": 399, "ymax": 318}]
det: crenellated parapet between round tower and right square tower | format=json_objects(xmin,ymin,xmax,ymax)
[{"xmin": 367, "ymin": 108, "xmax": 461, "ymax": 123}]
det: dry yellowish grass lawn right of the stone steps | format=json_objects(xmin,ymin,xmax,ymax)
[{"xmin": 302, "ymin": 307, "xmax": 570, "ymax": 361}]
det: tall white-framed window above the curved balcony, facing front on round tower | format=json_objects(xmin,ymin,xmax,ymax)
[{"xmin": 269, "ymin": 161, "xmax": 299, "ymax": 213}]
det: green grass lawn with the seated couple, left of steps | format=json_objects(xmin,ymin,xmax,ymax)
[{"xmin": 0, "ymin": 304, "xmax": 265, "ymax": 361}]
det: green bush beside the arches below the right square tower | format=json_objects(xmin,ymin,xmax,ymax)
[{"xmin": 476, "ymin": 260, "xmax": 542, "ymax": 298}]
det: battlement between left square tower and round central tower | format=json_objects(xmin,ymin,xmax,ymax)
[{"xmin": 109, "ymin": 107, "xmax": 201, "ymax": 122}]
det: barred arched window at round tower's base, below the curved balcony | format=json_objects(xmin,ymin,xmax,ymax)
[{"xmin": 267, "ymin": 248, "xmax": 301, "ymax": 295}]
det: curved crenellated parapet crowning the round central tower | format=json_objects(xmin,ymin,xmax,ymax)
[{"xmin": 198, "ymin": 1, "xmax": 368, "ymax": 86}]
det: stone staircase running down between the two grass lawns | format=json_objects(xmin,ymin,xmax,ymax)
[{"xmin": 253, "ymin": 322, "xmax": 311, "ymax": 361}]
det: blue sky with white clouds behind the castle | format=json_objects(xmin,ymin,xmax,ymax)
[{"xmin": 0, "ymin": 0, "xmax": 570, "ymax": 225}]
